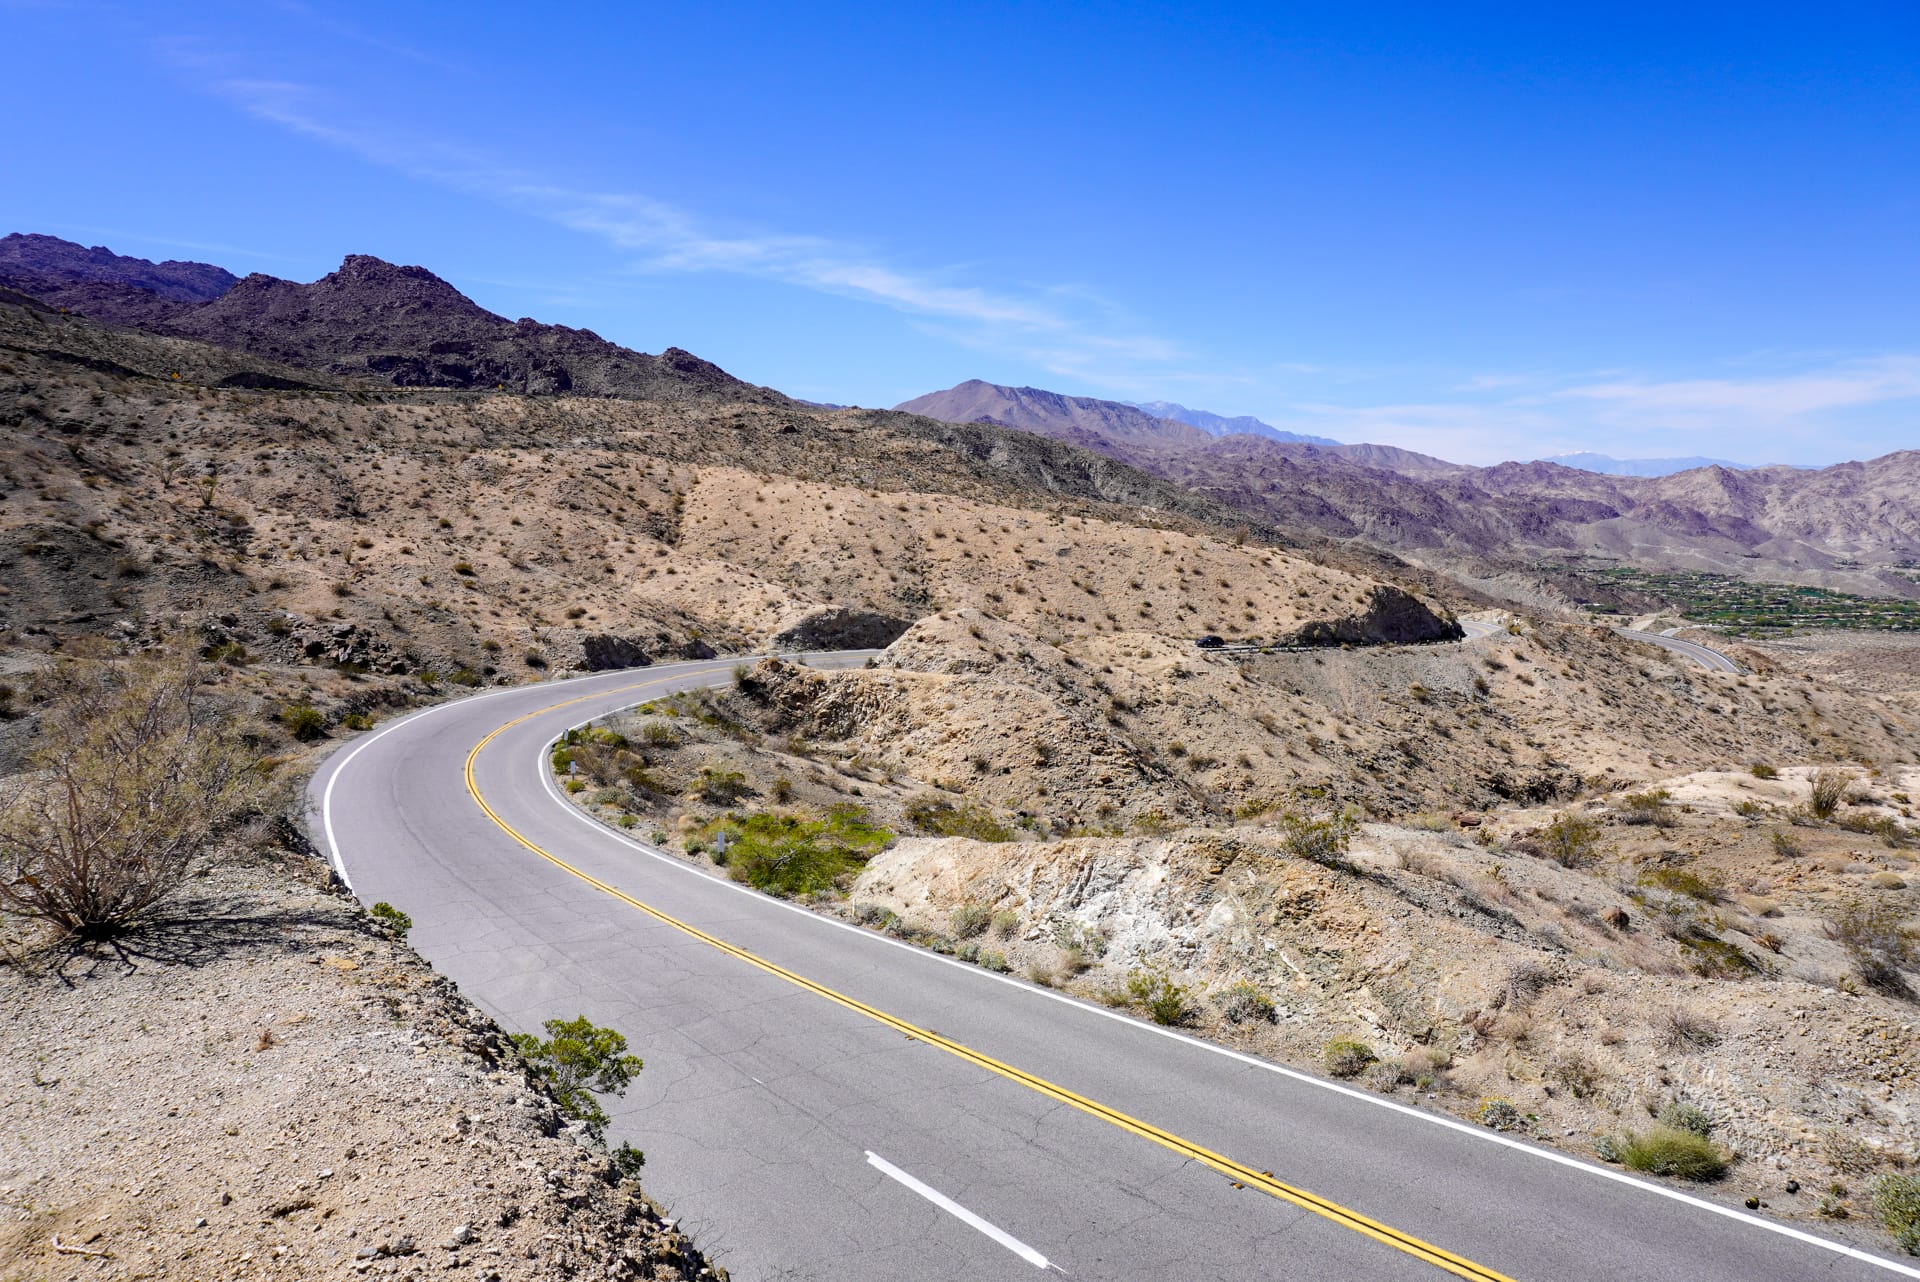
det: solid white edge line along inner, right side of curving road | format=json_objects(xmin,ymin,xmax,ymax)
[{"xmin": 518, "ymin": 675, "xmax": 1920, "ymax": 1278}]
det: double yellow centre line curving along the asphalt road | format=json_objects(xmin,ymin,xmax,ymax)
[{"xmin": 467, "ymin": 683, "xmax": 1513, "ymax": 1282}]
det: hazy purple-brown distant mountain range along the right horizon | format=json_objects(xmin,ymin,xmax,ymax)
[{"xmin": 899, "ymin": 380, "xmax": 1920, "ymax": 595}]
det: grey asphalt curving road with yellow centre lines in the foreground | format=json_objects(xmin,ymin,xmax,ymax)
[{"xmin": 309, "ymin": 654, "xmax": 1920, "ymax": 1282}]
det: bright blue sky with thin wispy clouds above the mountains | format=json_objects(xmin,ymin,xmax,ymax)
[{"xmin": 0, "ymin": 0, "xmax": 1920, "ymax": 463}]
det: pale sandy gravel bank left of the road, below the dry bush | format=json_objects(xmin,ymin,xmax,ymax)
[{"xmin": 0, "ymin": 856, "xmax": 726, "ymax": 1282}]
